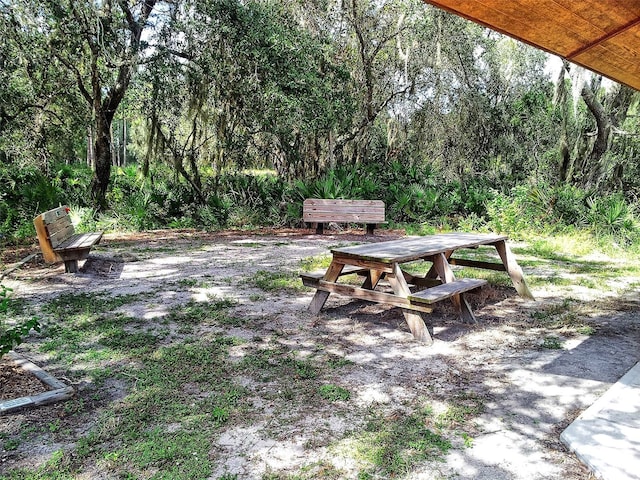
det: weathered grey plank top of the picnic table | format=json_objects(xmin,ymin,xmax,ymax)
[{"xmin": 331, "ymin": 233, "xmax": 508, "ymax": 264}]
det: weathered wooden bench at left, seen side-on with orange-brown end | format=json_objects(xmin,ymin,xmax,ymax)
[{"xmin": 33, "ymin": 205, "xmax": 102, "ymax": 273}]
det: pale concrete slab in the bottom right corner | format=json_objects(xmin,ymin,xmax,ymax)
[{"xmin": 560, "ymin": 363, "xmax": 640, "ymax": 480}]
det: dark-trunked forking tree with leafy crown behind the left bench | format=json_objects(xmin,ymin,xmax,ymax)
[{"xmin": 2, "ymin": 0, "xmax": 157, "ymax": 208}]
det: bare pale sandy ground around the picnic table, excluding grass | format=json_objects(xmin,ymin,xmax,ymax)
[{"xmin": 0, "ymin": 231, "xmax": 640, "ymax": 480}]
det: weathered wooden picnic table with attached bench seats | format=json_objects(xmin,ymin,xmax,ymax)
[{"xmin": 301, "ymin": 233, "xmax": 533, "ymax": 344}]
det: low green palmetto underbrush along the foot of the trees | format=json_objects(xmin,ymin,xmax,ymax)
[{"xmin": 0, "ymin": 165, "xmax": 640, "ymax": 250}]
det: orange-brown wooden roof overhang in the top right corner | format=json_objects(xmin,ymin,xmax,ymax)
[{"xmin": 425, "ymin": 0, "xmax": 640, "ymax": 90}]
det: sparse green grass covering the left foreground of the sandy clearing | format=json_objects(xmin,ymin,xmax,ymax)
[{"xmin": 3, "ymin": 286, "xmax": 247, "ymax": 479}]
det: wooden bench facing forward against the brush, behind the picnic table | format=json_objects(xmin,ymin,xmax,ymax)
[{"xmin": 302, "ymin": 198, "xmax": 387, "ymax": 235}]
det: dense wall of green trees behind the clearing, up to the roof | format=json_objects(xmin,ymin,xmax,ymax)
[{"xmin": 0, "ymin": 0, "xmax": 640, "ymax": 242}]
